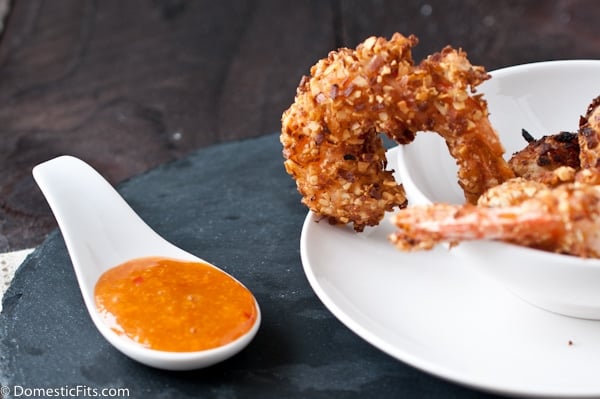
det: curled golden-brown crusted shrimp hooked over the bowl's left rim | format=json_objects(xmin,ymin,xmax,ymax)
[{"xmin": 280, "ymin": 33, "xmax": 513, "ymax": 231}]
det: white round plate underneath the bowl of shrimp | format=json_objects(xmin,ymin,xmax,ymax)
[{"xmin": 300, "ymin": 150, "xmax": 600, "ymax": 398}]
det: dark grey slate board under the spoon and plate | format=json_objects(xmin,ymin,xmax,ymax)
[{"xmin": 0, "ymin": 135, "xmax": 496, "ymax": 399}]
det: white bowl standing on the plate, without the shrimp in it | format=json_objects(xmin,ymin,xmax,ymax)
[{"xmin": 398, "ymin": 60, "xmax": 600, "ymax": 319}]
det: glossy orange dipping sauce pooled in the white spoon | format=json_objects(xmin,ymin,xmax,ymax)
[{"xmin": 94, "ymin": 257, "xmax": 258, "ymax": 352}]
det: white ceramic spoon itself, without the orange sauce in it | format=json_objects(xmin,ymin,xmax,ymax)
[{"xmin": 33, "ymin": 156, "xmax": 261, "ymax": 370}]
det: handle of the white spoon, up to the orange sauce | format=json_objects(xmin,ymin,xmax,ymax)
[{"xmin": 33, "ymin": 156, "xmax": 197, "ymax": 289}]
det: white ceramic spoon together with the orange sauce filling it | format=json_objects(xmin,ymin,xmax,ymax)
[{"xmin": 33, "ymin": 156, "xmax": 261, "ymax": 370}]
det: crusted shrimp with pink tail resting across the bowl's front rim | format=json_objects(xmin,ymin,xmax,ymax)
[{"xmin": 390, "ymin": 179, "xmax": 600, "ymax": 258}]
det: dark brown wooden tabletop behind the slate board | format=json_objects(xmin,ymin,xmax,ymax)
[{"xmin": 0, "ymin": 0, "xmax": 600, "ymax": 251}]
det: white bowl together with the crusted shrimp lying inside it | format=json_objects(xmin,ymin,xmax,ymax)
[{"xmin": 390, "ymin": 60, "xmax": 600, "ymax": 320}]
